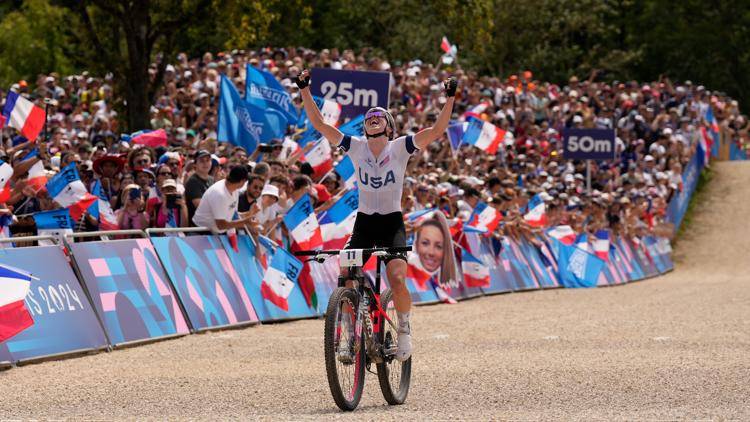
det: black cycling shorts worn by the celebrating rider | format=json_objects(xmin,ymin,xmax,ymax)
[{"xmin": 345, "ymin": 212, "xmax": 406, "ymax": 263}]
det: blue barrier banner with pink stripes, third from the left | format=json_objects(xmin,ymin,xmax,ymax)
[{"xmin": 151, "ymin": 236, "xmax": 258, "ymax": 330}]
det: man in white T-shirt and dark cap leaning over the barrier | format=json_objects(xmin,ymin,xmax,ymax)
[{"xmin": 193, "ymin": 165, "xmax": 252, "ymax": 233}]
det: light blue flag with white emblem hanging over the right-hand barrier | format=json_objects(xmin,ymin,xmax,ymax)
[{"xmin": 552, "ymin": 238, "xmax": 606, "ymax": 288}]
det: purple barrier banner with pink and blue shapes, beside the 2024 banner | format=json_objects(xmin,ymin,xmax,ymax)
[{"xmin": 71, "ymin": 239, "xmax": 190, "ymax": 346}]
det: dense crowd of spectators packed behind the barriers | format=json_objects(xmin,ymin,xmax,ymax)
[{"xmin": 0, "ymin": 48, "xmax": 748, "ymax": 246}]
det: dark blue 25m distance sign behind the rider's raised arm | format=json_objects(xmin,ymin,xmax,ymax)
[{"xmin": 310, "ymin": 67, "xmax": 391, "ymax": 118}]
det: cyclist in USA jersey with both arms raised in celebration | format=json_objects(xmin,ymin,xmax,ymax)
[{"xmin": 295, "ymin": 70, "xmax": 458, "ymax": 362}]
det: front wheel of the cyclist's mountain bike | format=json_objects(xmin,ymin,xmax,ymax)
[{"xmin": 324, "ymin": 287, "xmax": 366, "ymax": 411}]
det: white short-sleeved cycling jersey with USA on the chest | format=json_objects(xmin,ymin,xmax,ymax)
[{"xmin": 338, "ymin": 136, "xmax": 418, "ymax": 215}]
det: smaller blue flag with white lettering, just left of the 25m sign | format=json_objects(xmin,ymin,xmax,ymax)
[{"xmin": 245, "ymin": 65, "xmax": 298, "ymax": 125}]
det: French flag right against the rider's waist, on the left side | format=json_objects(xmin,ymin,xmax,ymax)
[{"xmin": 318, "ymin": 189, "xmax": 359, "ymax": 249}]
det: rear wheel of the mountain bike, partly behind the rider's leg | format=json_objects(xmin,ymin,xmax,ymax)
[{"xmin": 377, "ymin": 289, "xmax": 412, "ymax": 405}]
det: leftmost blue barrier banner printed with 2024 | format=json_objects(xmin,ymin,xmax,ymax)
[{"xmin": 0, "ymin": 246, "xmax": 108, "ymax": 362}]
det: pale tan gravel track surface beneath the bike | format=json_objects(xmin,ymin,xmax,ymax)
[{"xmin": 0, "ymin": 163, "xmax": 750, "ymax": 420}]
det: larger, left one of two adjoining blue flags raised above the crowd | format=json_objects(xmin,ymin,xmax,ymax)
[{"xmin": 216, "ymin": 75, "xmax": 287, "ymax": 154}]
